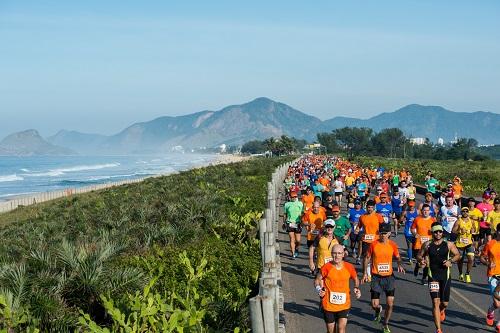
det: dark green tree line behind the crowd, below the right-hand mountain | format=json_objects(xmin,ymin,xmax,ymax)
[{"xmin": 318, "ymin": 127, "xmax": 489, "ymax": 161}]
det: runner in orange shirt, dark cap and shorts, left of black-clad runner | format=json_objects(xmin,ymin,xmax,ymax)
[{"xmin": 363, "ymin": 223, "xmax": 405, "ymax": 333}]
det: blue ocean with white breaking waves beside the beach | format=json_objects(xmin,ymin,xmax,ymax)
[{"xmin": 0, "ymin": 153, "xmax": 217, "ymax": 201}]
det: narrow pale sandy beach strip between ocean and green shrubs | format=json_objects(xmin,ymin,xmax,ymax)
[{"xmin": 0, "ymin": 154, "xmax": 251, "ymax": 213}]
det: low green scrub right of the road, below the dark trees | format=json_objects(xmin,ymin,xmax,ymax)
[{"xmin": 353, "ymin": 156, "xmax": 500, "ymax": 196}]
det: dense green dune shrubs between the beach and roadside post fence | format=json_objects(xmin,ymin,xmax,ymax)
[{"xmin": 0, "ymin": 159, "xmax": 292, "ymax": 332}]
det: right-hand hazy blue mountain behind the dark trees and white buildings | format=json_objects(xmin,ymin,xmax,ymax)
[{"xmin": 323, "ymin": 104, "xmax": 500, "ymax": 144}]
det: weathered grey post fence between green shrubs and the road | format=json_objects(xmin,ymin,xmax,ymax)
[{"xmin": 250, "ymin": 161, "xmax": 295, "ymax": 333}]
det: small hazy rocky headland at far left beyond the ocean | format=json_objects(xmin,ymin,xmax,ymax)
[{"xmin": 0, "ymin": 129, "xmax": 75, "ymax": 156}]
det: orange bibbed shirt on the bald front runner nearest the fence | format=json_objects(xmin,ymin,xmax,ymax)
[{"xmin": 321, "ymin": 262, "xmax": 356, "ymax": 312}]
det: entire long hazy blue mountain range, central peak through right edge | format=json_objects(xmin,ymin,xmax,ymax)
[{"xmin": 2, "ymin": 97, "xmax": 500, "ymax": 154}]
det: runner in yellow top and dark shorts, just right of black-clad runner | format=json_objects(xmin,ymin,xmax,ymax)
[{"xmin": 453, "ymin": 207, "xmax": 476, "ymax": 283}]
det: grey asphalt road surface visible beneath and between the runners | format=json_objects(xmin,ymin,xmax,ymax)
[{"xmin": 279, "ymin": 191, "xmax": 494, "ymax": 333}]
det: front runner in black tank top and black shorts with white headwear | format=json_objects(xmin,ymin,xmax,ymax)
[{"xmin": 417, "ymin": 222, "xmax": 460, "ymax": 333}]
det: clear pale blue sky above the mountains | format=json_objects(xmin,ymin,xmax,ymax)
[{"xmin": 0, "ymin": 0, "xmax": 500, "ymax": 139}]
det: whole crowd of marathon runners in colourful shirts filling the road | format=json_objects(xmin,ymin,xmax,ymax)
[{"xmin": 283, "ymin": 156, "xmax": 500, "ymax": 333}]
